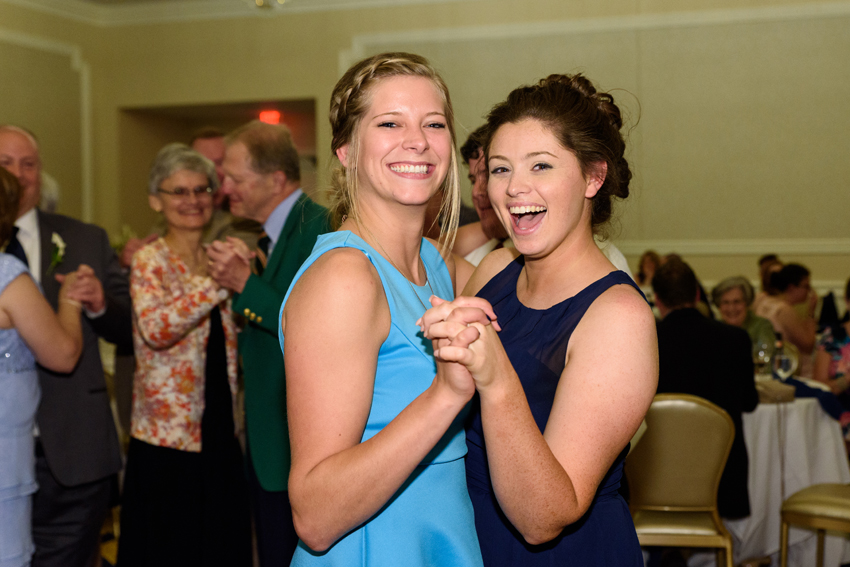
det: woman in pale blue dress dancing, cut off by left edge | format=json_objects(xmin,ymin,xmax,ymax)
[{"xmin": 0, "ymin": 167, "xmax": 83, "ymax": 567}]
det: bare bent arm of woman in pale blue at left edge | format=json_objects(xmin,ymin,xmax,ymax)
[{"xmin": 0, "ymin": 274, "xmax": 83, "ymax": 373}]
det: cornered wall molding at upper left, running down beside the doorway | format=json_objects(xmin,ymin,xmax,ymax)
[{"xmin": 0, "ymin": 28, "xmax": 94, "ymax": 222}]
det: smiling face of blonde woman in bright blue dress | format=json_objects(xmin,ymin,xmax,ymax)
[{"xmin": 337, "ymin": 76, "xmax": 453, "ymax": 217}]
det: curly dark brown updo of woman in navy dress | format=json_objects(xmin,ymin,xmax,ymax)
[{"xmin": 484, "ymin": 73, "xmax": 632, "ymax": 233}]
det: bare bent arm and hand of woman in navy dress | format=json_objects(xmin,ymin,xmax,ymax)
[{"xmin": 428, "ymin": 286, "xmax": 658, "ymax": 544}]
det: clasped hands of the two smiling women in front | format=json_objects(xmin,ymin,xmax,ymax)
[{"xmin": 417, "ymin": 296, "xmax": 501, "ymax": 388}]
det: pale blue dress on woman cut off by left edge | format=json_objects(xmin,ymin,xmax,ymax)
[{"xmin": 0, "ymin": 254, "xmax": 41, "ymax": 567}]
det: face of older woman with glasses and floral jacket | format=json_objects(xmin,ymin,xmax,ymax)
[{"xmin": 150, "ymin": 169, "xmax": 212, "ymax": 231}]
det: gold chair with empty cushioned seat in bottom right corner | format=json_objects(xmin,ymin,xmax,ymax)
[{"xmin": 779, "ymin": 484, "xmax": 850, "ymax": 567}]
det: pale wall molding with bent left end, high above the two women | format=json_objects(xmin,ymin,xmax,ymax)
[{"xmin": 338, "ymin": 1, "xmax": 850, "ymax": 71}]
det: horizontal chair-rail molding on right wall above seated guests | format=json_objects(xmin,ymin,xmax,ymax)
[{"xmin": 612, "ymin": 238, "xmax": 850, "ymax": 256}]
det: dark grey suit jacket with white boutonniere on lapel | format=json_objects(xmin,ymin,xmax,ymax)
[{"xmin": 36, "ymin": 211, "xmax": 132, "ymax": 486}]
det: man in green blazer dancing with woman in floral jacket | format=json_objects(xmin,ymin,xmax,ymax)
[{"xmin": 207, "ymin": 121, "xmax": 329, "ymax": 567}]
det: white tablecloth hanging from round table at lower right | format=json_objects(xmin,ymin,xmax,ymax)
[{"xmin": 688, "ymin": 398, "xmax": 850, "ymax": 567}]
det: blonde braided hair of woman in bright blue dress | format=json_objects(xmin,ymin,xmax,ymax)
[{"xmin": 329, "ymin": 52, "xmax": 460, "ymax": 250}]
